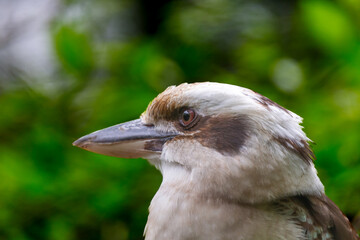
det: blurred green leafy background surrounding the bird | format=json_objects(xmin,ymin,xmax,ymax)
[{"xmin": 0, "ymin": 0, "xmax": 360, "ymax": 240}]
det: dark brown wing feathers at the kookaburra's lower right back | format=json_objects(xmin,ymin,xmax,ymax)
[{"xmin": 277, "ymin": 195, "xmax": 360, "ymax": 240}]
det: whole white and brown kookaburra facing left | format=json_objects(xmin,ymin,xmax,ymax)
[{"xmin": 74, "ymin": 82, "xmax": 359, "ymax": 240}]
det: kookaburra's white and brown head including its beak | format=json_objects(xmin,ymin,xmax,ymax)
[{"xmin": 74, "ymin": 82, "xmax": 324, "ymax": 203}]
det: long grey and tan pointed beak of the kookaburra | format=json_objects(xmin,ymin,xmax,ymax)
[{"xmin": 73, "ymin": 119, "xmax": 177, "ymax": 158}]
